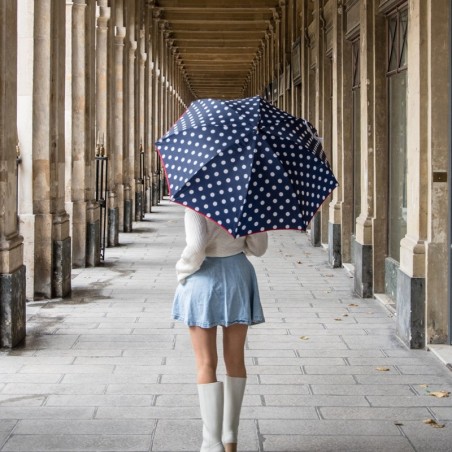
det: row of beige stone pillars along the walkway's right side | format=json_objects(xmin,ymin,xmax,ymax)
[{"xmin": 245, "ymin": 0, "xmax": 451, "ymax": 348}]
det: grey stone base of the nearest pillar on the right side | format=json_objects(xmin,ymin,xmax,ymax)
[{"xmin": 396, "ymin": 269, "xmax": 425, "ymax": 348}]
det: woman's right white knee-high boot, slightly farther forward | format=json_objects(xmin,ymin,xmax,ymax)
[{"xmin": 223, "ymin": 375, "xmax": 246, "ymax": 444}]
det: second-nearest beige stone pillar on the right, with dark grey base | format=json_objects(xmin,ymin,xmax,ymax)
[{"xmin": 354, "ymin": 0, "xmax": 387, "ymax": 297}]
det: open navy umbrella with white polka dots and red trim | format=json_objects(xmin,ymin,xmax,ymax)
[{"xmin": 155, "ymin": 96, "xmax": 338, "ymax": 237}]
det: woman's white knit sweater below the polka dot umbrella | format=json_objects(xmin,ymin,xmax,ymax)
[{"xmin": 176, "ymin": 209, "xmax": 268, "ymax": 282}]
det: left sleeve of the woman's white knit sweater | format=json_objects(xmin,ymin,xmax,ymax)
[{"xmin": 176, "ymin": 209, "xmax": 207, "ymax": 282}]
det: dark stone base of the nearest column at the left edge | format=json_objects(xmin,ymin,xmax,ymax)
[{"xmin": 0, "ymin": 265, "xmax": 26, "ymax": 348}]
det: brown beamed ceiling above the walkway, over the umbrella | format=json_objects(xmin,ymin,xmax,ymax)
[{"xmin": 155, "ymin": 0, "xmax": 279, "ymax": 98}]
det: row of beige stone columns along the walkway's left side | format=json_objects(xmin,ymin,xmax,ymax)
[{"xmin": 0, "ymin": 0, "xmax": 193, "ymax": 347}]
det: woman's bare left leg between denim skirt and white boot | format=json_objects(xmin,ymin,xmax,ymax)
[{"xmin": 190, "ymin": 326, "xmax": 218, "ymax": 384}]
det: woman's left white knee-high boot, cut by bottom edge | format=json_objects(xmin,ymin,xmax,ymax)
[{"xmin": 198, "ymin": 381, "xmax": 224, "ymax": 452}]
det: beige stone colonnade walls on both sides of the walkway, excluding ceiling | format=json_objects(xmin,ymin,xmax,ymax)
[{"xmin": 0, "ymin": 0, "xmax": 451, "ymax": 348}]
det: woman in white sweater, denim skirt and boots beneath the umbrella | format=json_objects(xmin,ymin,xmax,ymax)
[{"xmin": 172, "ymin": 209, "xmax": 268, "ymax": 452}]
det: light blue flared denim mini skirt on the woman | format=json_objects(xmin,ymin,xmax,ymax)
[{"xmin": 172, "ymin": 253, "xmax": 265, "ymax": 328}]
